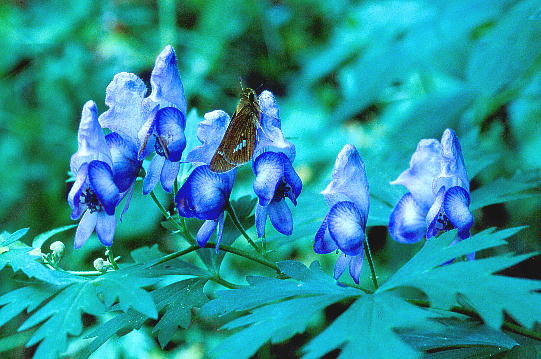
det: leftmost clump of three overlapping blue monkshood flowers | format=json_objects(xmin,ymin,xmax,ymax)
[{"xmin": 68, "ymin": 46, "xmax": 186, "ymax": 248}]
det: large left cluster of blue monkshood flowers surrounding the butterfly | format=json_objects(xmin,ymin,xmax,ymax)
[{"xmin": 68, "ymin": 46, "xmax": 302, "ymax": 249}]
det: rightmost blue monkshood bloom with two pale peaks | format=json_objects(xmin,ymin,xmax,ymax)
[{"xmin": 389, "ymin": 129, "xmax": 473, "ymax": 250}]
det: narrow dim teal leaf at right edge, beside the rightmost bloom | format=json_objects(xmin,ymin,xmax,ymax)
[{"xmin": 470, "ymin": 174, "xmax": 540, "ymax": 211}]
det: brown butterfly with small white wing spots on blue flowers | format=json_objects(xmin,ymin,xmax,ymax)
[{"xmin": 210, "ymin": 88, "xmax": 261, "ymax": 173}]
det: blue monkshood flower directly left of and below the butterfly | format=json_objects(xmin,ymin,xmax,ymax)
[{"xmin": 175, "ymin": 110, "xmax": 237, "ymax": 250}]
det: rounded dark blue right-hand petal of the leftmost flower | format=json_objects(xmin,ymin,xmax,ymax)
[{"xmin": 88, "ymin": 161, "xmax": 120, "ymax": 215}]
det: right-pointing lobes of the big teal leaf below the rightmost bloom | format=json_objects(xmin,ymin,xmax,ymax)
[{"xmin": 378, "ymin": 228, "xmax": 541, "ymax": 329}]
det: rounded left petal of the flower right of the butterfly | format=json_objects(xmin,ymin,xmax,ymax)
[{"xmin": 253, "ymin": 152, "xmax": 289, "ymax": 206}]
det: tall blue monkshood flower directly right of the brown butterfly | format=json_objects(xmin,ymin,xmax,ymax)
[{"xmin": 252, "ymin": 91, "xmax": 302, "ymax": 238}]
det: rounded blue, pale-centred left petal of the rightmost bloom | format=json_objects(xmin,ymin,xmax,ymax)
[{"xmin": 389, "ymin": 192, "xmax": 427, "ymax": 243}]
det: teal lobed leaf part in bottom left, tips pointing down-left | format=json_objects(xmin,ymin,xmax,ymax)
[{"xmin": 19, "ymin": 281, "xmax": 105, "ymax": 359}]
